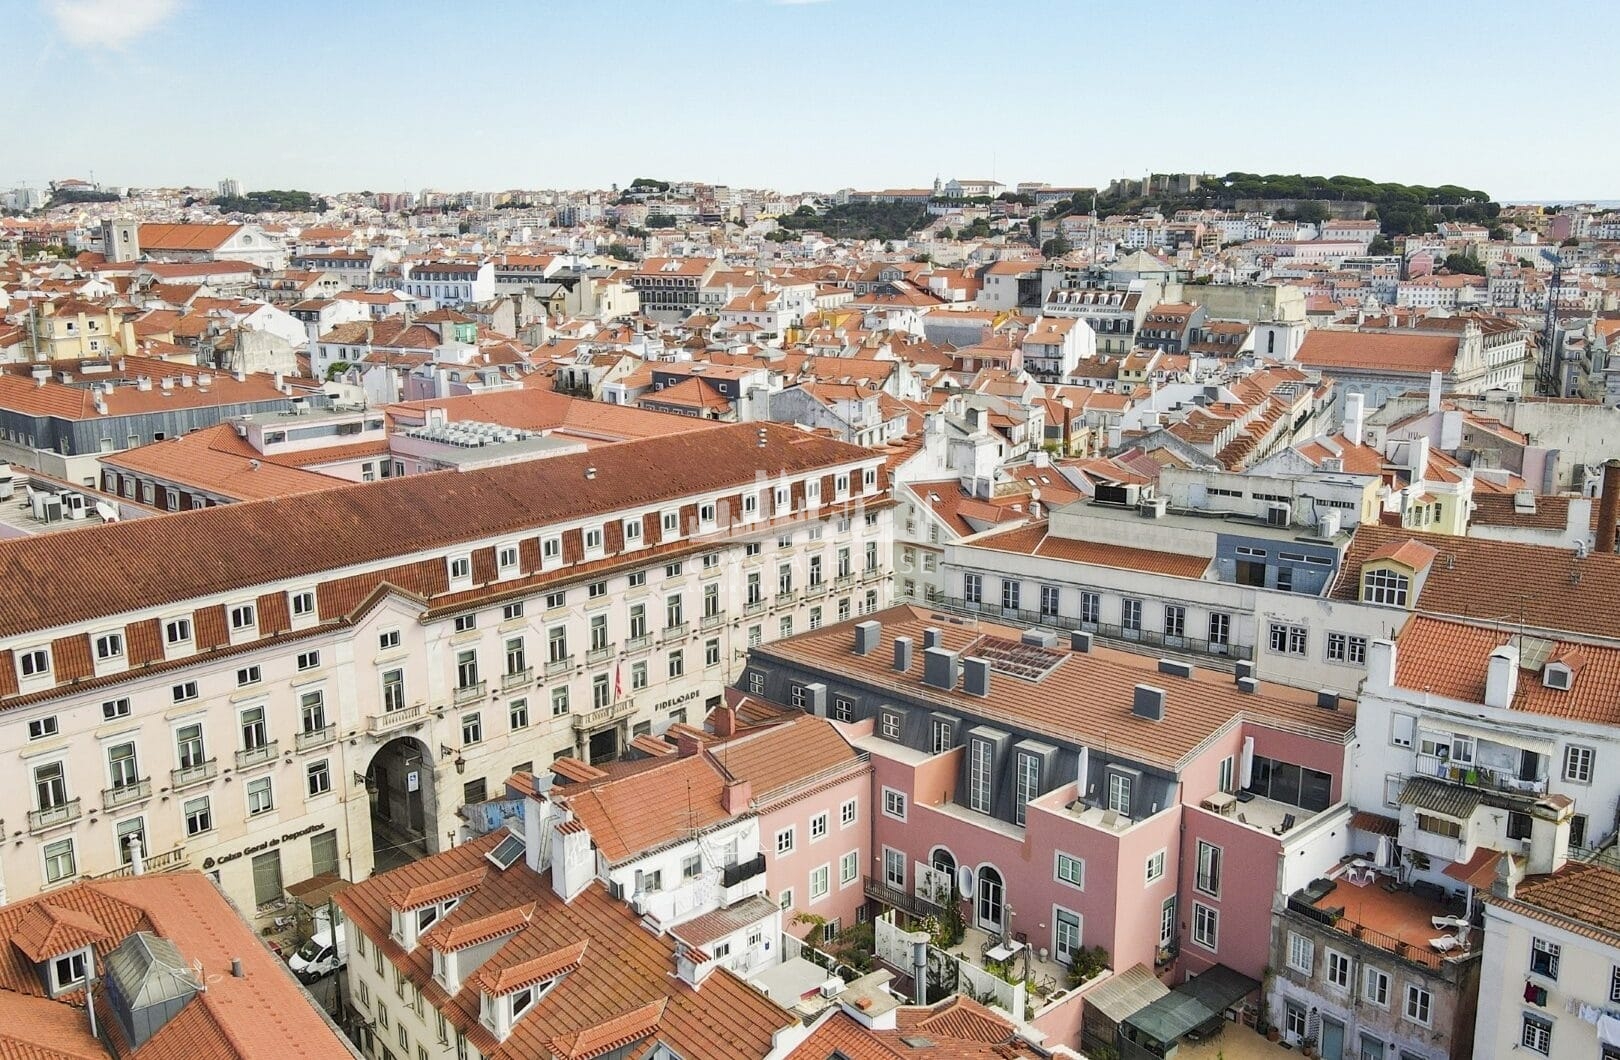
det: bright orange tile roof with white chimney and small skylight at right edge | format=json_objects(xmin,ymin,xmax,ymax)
[{"xmin": 1395, "ymin": 619, "xmax": 1620, "ymax": 724}]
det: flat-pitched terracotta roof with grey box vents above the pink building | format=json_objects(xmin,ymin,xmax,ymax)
[{"xmin": 753, "ymin": 606, "xmax": 1356, "ymax": 768}]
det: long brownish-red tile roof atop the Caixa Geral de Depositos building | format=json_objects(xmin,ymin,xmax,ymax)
[{"xmin": 0, "ymin": 423, "xmax": 872, "ymax": 637}]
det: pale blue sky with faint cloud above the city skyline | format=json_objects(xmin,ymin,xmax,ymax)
[{"xmin": 0, "ymin": 0, "xmax": 1620, "ymax": 201}]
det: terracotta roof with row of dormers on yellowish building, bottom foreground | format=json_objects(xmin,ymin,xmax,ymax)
[{"xmin": 337, "ymin": 831, "xmax": 792, "ymax": 1060}]
